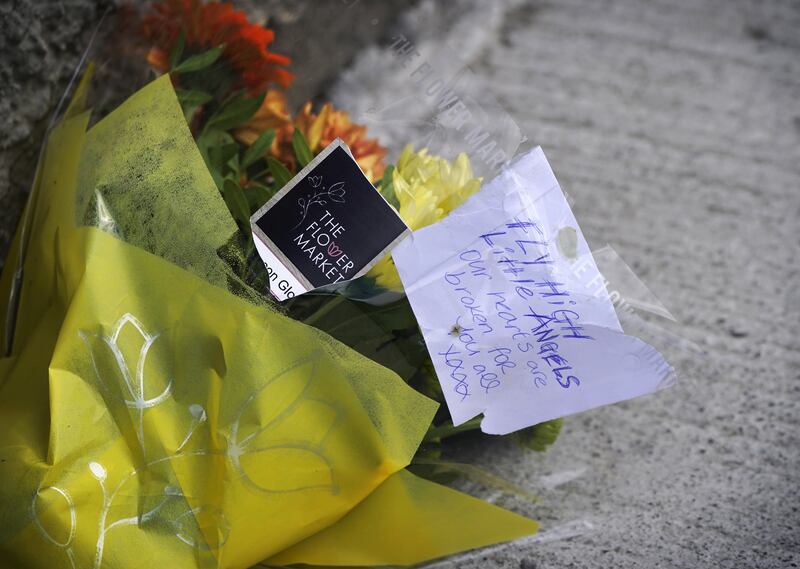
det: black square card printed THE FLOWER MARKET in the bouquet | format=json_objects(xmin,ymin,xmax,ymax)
[{"xmin": 250, "ymin": 139, "xmax": 409, "ymax": 300}]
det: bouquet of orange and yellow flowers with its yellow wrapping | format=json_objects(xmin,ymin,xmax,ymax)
[{"xmin": 0, "ymin": 0, "xmax": 680, "ymax": 569}]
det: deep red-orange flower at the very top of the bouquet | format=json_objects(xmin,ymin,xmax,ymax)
[{"xmin": 144, "ymin": 0, "xmax": 294, "ymax": 94}]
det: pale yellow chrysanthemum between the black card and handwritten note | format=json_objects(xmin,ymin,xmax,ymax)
[{"xmin": 369, "ymin": 144, "xmax": 482, "ymax": 291}]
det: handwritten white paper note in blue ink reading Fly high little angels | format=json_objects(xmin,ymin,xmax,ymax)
[{"xmin": 392, "ymin": 148, "xmax": 674, "ymax": 434}]
